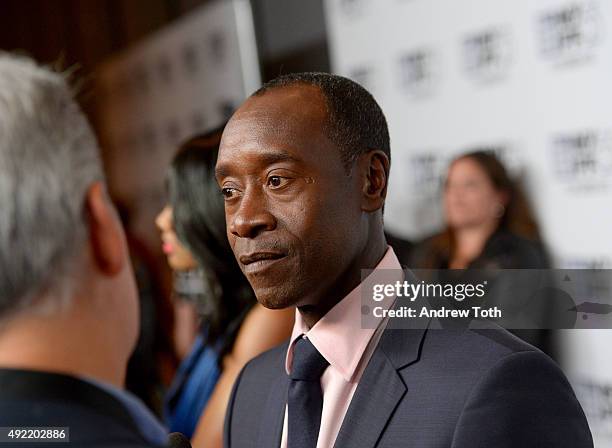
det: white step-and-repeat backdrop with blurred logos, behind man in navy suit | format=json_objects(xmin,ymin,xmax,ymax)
[{"xmin": 325, "ymin": 0, "xmax": 612, "ymax": 447}]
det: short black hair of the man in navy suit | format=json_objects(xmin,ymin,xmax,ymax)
[{"xmin": 253, "ymin": 72, "xmax": 391, "ymax": 169}]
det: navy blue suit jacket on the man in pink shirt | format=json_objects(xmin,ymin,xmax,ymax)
[{"xmin": 225, "ymin": 324, "xmax": 593, "ymax": 448}]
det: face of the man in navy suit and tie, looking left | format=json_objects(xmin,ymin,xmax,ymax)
[{"xmin": 217, "ymin": 85, "xmax": 363, "ymax": 308}]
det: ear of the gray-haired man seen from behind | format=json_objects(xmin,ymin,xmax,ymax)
[{"xmin": 86, "ymin": 182, "xmax": 126, "ymax": 276}]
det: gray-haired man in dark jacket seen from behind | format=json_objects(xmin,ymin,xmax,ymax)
[{"xmin": 0, "ymin": 53, "xmax": 165, "ymax": 448}]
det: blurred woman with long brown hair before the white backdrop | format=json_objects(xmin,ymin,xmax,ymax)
[{"xmin": 410, "ymin": 151, "xmax": 549, "ymax": 269}]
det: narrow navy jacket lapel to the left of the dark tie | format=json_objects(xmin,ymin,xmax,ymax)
[{"xmin": 256, "ymin": 368, "xmax": 289, "ymax": 447}]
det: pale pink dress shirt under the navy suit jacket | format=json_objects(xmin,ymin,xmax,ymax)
[{"xmin": 281, "ymin": 247, "xmax": 404, "ymax": 448}]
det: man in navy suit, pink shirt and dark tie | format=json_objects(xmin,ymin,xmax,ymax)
[{"xmin": 216, "ymin": 73, "xmax": 593, "ymax": 448}]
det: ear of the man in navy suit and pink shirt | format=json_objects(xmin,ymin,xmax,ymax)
[{"xmin": 359, "ymin": 149, "xmax": 390, "ymax": 212}]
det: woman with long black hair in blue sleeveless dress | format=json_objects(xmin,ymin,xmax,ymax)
[{"xmin": 156, "ymin": 128, "xmax": 294, "ymax": 448}]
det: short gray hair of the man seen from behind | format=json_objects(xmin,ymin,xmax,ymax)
[{"xmin": 0, "ymin": 52, "xmax": 103, "ymax": 318}]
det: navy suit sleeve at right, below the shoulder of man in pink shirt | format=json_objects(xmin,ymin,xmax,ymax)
[{"xmin": 451, "ymin": 351, "xmax": 593, "ymax": 448}]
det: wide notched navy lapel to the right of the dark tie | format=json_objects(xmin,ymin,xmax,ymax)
[{"xmin": 334, "ymin": 329, "xmax": 426, "ymax": 448}]
